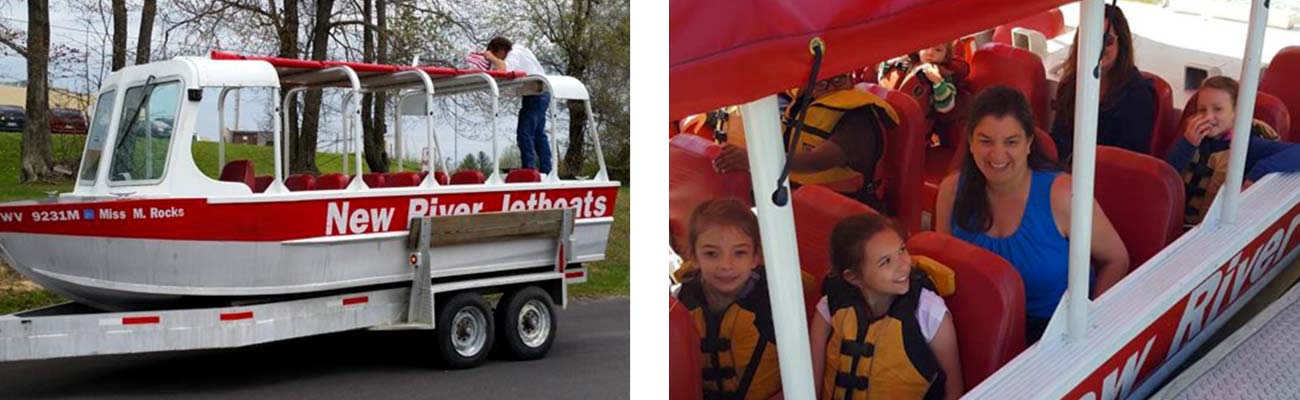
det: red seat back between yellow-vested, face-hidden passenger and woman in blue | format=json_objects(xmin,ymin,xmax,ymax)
[{"xmin": 862, "ymin": 83, "xmax": 931, "ymax": 232}]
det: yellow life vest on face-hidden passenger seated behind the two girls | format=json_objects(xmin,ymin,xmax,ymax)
[{"xmin": 785, "ymin": 88, "xmax": 898, "ymax": 194}]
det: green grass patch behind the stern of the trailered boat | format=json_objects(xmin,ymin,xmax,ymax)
[{"xmin": 569, "ymin": 186, "xmax": 632, "ymax": 297}]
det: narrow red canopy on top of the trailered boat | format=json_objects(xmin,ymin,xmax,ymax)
[{"xmin": 211, "ymin": 51, "xmax": 527, "ymax": 86}]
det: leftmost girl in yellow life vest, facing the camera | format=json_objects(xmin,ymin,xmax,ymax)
[{"xmin": 676, "ymin": 199, "xmax": 781, "ymax": 399}]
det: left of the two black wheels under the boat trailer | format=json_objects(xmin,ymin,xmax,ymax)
[{"xmin": 434, "ymin": 292, "xmax": 495, "ymax": 369}]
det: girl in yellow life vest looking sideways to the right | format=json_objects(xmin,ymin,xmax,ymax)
[{"xmin": 809, "ymin": 214, "xmax": 962, "ymax": 400}]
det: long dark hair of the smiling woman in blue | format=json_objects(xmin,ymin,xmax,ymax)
[{"xmin": 953, "ymin": 86, "xmax": 1058, "ymax": 232}]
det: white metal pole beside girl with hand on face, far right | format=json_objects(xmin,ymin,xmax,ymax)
[{"xmin": 1219, "ymin": 0, "xmax": 1269, "ymax": 223}]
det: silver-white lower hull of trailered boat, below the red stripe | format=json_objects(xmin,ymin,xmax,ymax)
[{"xmin": 0, "ymin": 218, "xmax": 612, "ymax": 303}]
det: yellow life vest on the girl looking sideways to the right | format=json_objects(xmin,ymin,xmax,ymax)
[{"xmin": 820, "ymin": 270, "xmax": 945, "ymax": 400}]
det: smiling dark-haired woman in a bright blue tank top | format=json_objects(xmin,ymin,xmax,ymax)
[{"xmin": 935, "ymin": 86, "xmax": 1128, "ymax": 343}]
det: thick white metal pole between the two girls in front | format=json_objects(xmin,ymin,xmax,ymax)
[{"xmin": 741, "ymin": 96, "xmax": 814, "ymax": 399}]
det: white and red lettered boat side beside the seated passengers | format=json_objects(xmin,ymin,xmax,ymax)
[{"xmin": 967, "ymin": 174, "xmax": 1300, "ymax": 400}]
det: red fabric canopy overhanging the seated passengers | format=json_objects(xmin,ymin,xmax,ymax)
[{"xmin": 668, "ymin": 0, "xmax": 1070, "ymax": 119}]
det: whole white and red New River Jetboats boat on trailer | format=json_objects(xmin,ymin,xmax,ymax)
[{"xmin": 0, "ymin": 52, "xmax": 619, "ymax": 309}]
